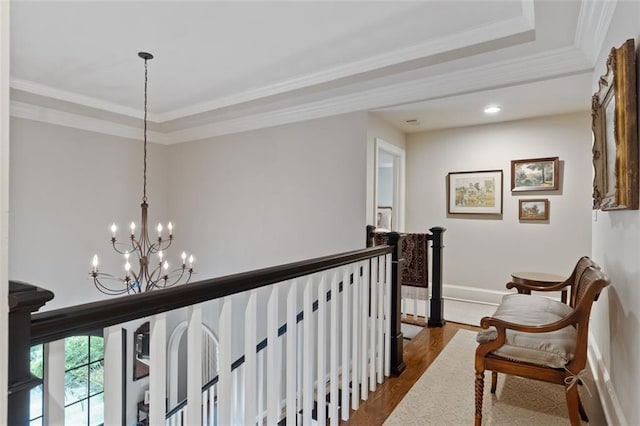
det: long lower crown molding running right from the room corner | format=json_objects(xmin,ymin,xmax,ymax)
[{"xmin": 167, "ymin": 46, "xmax": 592, "ymax": 144}]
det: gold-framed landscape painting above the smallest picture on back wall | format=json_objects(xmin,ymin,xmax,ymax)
[{"xmin": 511, "ymin": 157, "xmax": 560, "ymax": 192}]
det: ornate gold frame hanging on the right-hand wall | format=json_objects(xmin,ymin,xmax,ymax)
[{"xmin": 591, "ymin": 39, "xmax": 638, "ymax": 210}]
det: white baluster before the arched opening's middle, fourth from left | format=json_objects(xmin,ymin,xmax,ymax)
[{"xmin": 186, "ymin": 304, "xmax": 202, "ymax": 425}]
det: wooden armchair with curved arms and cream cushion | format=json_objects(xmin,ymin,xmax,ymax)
[{"xmin": 475, "ymin": 257, "xmax": 609, "ymax": 426}]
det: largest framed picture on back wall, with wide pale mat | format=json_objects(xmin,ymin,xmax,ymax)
[{"xmin": 447, "ymin": 170, "xmax": 502, "ymax": 214}]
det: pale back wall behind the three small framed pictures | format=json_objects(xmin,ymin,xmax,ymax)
[{"xmin": 406, "ymin": 112, "xmax": 591, "ymax": 302}]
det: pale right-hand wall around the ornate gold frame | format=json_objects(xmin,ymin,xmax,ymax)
[{"xmin": 590, "ymin": 1, "xmax": 640, "ymax": 425}]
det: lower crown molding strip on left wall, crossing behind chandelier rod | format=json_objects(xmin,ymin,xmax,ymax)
[{"xmin": 10, "ymin": 101, "xmax": 168, "ymax": 145}]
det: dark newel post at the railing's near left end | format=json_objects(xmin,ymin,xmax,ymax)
[{"xmin": 7, "ymin": 281, "xmax": 53, "ymax": 425}]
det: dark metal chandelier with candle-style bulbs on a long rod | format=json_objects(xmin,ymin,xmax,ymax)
[{"xmin": 89, "ymin": 52, "xmax": 193, "ymax": 295}]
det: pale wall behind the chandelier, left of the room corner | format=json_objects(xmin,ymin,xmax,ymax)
[{"xmin": 9, "ymin": 118, "xmax": 170, "ymax": 310}]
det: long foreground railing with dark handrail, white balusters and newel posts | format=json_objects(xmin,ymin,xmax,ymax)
[{"xmin": 8, "ymin": 233, "xmax": 404, "ymax": 425}]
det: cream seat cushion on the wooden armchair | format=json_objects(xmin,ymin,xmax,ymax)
[{"xmin": 476, "ymin": 294, "xmax": 577, "ymax": 368}]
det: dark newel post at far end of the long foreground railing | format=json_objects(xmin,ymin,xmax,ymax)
[{"xmin": 387, "ymin": 232, "xmax": 405, "ymax": 376}]
